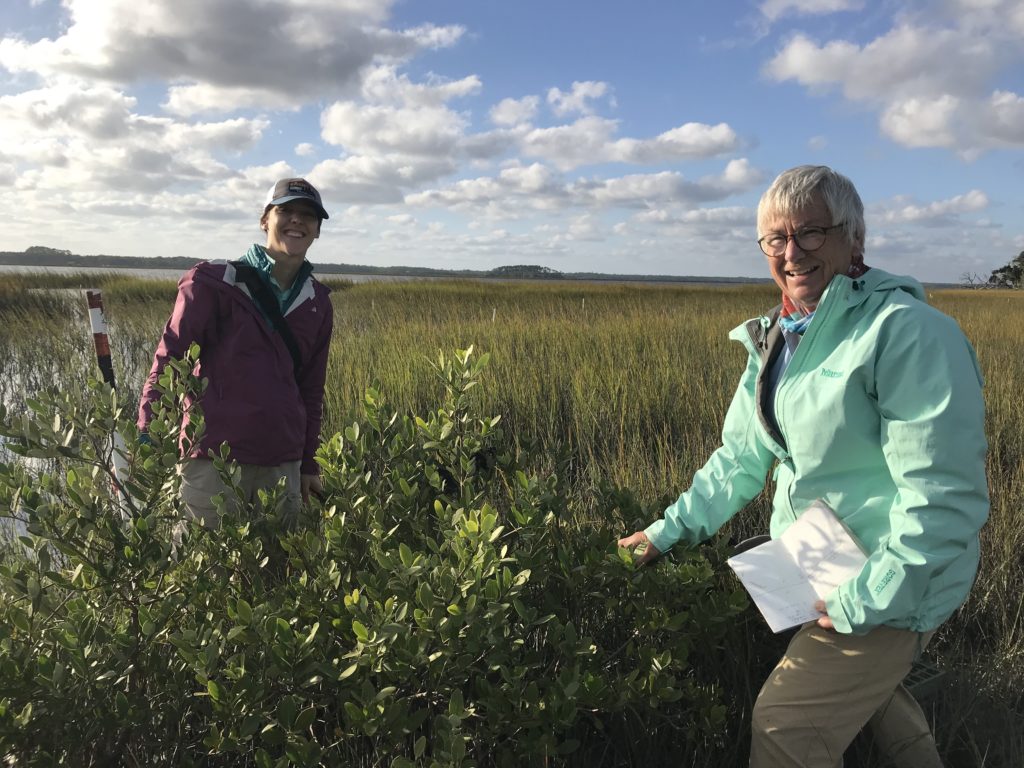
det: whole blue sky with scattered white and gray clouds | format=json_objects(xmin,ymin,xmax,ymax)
[{"xmin": 0, "ymin": 0, "xmax": 1024, "ymax": 281}]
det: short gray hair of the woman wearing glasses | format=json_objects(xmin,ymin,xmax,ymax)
[{"xmin": 758, "ymin": 165, "xmax": 866, "ymax": 246}]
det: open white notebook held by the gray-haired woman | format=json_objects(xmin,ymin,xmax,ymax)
[{"xmin": 727, "ymin": 501, "xmax": 867, "ymax": 632}]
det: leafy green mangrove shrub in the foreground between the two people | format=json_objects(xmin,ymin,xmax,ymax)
[{"xmin": 0, "ymin": 350, "xmax": 745, "ymax": 768}]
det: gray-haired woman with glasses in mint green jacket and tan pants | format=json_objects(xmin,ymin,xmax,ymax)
[{"xmin": 620, "ymin": 166, "xmax": 988, "ymax": 768}]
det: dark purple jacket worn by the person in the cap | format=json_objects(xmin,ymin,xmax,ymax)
[{"xmin": 138, "ymin": 261, "xmax": 334, "ymax": 474}]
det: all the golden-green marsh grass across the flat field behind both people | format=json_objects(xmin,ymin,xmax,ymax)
[{"xmin": 0, "ymin": 275, "xmax": 1024, "ymax": 768}]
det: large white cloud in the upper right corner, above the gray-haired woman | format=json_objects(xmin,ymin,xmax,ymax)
[{"xmin": 764, "ymin": 17, "xmax": 1024, "ymax": 157}]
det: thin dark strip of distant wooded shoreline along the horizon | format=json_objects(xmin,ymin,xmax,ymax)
[{"xmin": 0, "ymin": 246, "xmax": 771, "ymax": 284}]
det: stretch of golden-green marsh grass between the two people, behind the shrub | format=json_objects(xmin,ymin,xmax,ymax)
[{"xmin": 329, "ymin": 283, "xmax": 750, "ymax": 494}]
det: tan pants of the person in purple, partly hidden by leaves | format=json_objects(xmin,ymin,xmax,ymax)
[{"xmin": 175, "ymin": 459, "xmax": 302, "ymax": 539}]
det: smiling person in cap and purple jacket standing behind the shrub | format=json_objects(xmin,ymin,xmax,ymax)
[{"xmin": 138, "ymin": 178, "xmax": 334, "ymax": 527}]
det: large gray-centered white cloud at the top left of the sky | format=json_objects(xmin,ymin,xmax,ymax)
[{"xmin": 0, "ymin": 0, "xmax": 464, "ymax": 115}]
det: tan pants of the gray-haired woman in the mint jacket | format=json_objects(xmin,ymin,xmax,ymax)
[{"xmin": 750, "ymin": 624, "xmax": 942, "ymax": 768}]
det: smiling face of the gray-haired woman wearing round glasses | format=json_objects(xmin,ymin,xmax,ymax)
[{"xmin": 761, "ymin": 198, "xmax": 862, "ymax": 311}]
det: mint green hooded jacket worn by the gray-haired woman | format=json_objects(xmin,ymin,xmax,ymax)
[{"xmin": 645, "ymin": 269, "xmax": 988, "ymax": 634}]
